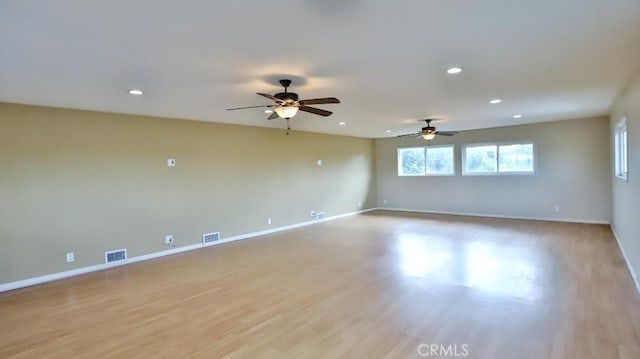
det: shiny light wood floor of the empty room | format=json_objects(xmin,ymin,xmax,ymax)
[{"xmin": 0, "ymin": 211, "xmax": 640, "ymax": 359}]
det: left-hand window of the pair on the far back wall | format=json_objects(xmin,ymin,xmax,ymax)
[{"xmin": 398, "ymin": 145, "xmax": 455, "ymax": 176}]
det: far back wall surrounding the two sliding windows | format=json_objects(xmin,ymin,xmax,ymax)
[{"xmin": 376, "ymin": 118, "xmax": 611, "ymax": 222}]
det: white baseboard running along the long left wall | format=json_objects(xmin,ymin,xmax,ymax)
[{"xmin": 0, "ymin": 207, "xmax": 377, "ymax": 293}]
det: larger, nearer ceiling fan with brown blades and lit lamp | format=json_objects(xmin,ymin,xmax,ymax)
[{"xmin": 227, "ymin": 79, "xmax": 340, "ymax": 121}]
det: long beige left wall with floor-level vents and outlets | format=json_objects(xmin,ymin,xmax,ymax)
[{"xmin": 0, "ymin": 104, "xmax": 376, "ymax": 283}]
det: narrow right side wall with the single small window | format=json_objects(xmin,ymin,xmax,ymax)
[{"xmin": 609, "ymin": 70, "xmax": 640, "ymax": 284}]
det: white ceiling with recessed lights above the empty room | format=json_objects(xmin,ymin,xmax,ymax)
[{"xmin": 0, "ymin": 0, "xmax": 640, "ymax": 138}]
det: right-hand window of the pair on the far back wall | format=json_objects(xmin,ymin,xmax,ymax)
[{"xmin": 462, "ymin": 142, "xmax": 535, "ymax": 175}]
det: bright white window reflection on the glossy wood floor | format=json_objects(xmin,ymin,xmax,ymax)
[{"xmin": 397, "ymin": 229, "xmax": 549, "ymax": 302}]
